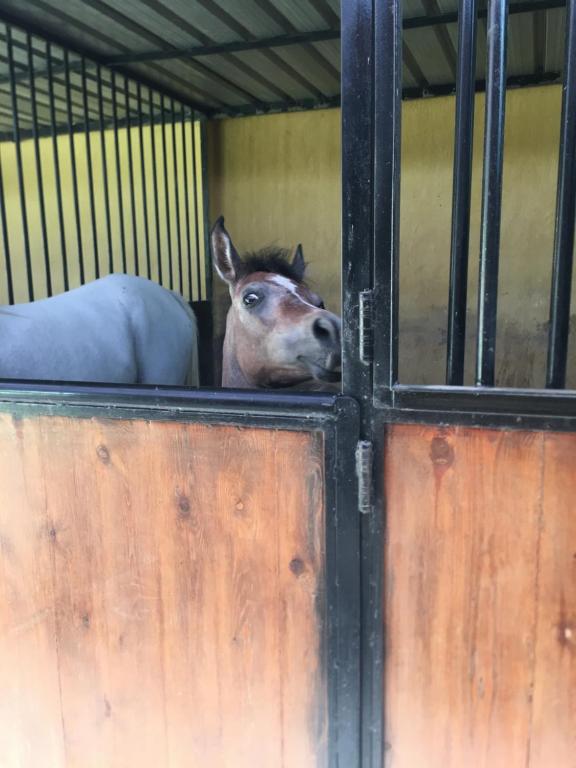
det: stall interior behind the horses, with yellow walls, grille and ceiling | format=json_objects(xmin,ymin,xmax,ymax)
[{"xmin": 0, "ymin": 0, "xmax": 576, "ymax": 387}]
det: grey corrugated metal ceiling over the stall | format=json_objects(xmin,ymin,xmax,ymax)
[{"xmin": 0, "ymin": 0, "xmax": 564, "ymax": 119}]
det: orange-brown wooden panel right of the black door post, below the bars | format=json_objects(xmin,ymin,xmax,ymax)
[{"xmin": 385, "ymin": 425, "xmax": 576, "ymax": 768}]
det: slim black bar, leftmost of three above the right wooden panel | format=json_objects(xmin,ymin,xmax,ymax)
[{"xmin": 446, "ymin": 0, "xmax": 478, "ymax": 386}]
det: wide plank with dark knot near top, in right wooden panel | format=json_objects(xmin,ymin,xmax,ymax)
[{"xmin": 385, "ymin": 425, "xmax": 544, "ymax": 768}]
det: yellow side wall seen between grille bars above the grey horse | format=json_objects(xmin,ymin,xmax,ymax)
[{"xmin": 0, "ymin": 124, "xmax": 205, "ymax": 303}]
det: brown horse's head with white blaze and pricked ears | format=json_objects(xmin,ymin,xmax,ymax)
[{"xmin": 211, "ymin": 217, "xmax": 341, "ymax": 389}]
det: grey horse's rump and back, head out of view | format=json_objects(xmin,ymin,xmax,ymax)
[{"xmin": 0, "ymin": 275, "xmax": 198, "ymax": 386}]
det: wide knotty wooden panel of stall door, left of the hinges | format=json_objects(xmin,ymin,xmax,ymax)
[{"xmin": 0, "ymin": 415, "xmax": 327, "ymax": 768}]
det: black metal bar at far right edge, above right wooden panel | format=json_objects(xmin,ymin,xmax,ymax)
[{"xmin": 546, "ymin": 0, "xmax": 576, "ymax": 389}]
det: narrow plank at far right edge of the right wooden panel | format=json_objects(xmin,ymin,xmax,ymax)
[{"xmin": 528, "ymin": 434, "xmax": 576, "ymax": 768}]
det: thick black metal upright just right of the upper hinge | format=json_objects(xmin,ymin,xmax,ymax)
[{"xmin": 373, "ymin": 0, "xmax": 402, "ymax": 396}]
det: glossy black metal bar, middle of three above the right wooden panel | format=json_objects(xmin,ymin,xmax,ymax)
[{"xmin": 476, "ymin": 0, "xmax": 508, "ymax": 387}]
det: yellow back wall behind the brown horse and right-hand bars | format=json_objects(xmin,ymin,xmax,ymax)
[{"xmin": 209, "ymin": 86, "xmax": 576, "ymax": 386}]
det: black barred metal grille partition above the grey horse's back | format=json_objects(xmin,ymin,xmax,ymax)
[{"xmin": 0, "ymin": 24, "xmax": 209, "ymax": 304}]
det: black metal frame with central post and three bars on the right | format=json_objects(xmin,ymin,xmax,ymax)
[{"xmin": 342, "ymin": 0, "xmax": 576, "ymax": 768}]
